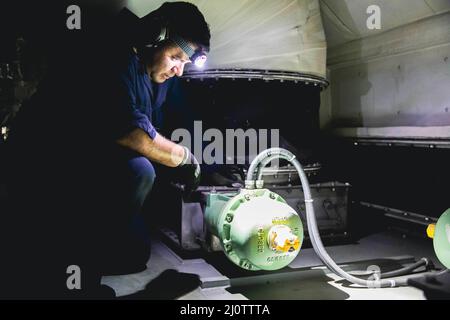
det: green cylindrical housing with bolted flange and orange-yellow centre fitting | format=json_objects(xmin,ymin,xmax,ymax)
[{"xmin": 205, "ymin": 189, "xmax": 303, "ymax": 270}]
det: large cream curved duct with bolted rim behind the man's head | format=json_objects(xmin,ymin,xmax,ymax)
[{"xmin": 128, "ymin": 0, "xmax": 327, "ymax": 85}]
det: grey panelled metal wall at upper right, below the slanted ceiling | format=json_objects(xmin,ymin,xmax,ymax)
[{"xmin": 322, "ymin": 12, "xmax": 450, "ymax": 131}]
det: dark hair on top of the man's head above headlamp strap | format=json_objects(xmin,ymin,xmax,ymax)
[{"xmin": 142, "ymin": 2, "xmax": 211, "ymax": 51}]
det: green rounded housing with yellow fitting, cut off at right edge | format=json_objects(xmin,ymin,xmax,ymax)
[{"xmin": 427, "ymin": 209, "xmax": 450, "ymax": 268}]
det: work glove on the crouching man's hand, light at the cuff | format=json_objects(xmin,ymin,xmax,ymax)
[{"xmin": 175, "ymin": 147, "xmax": 200, "ymax": 194}]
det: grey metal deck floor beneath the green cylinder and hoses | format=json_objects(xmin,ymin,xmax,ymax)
[{"xmin": 102, "ymin": 232, "xmax": 442, "ymax": 300}]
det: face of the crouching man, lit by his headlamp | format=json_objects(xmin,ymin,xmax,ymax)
[{"xmin": 147, "ymin": 45, "xmax": 191, "ymax": 83}]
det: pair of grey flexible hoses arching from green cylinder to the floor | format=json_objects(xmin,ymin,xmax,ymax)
[{"xmin": 246, "ymin": 148, "xmax": 434, "ymax": 288}]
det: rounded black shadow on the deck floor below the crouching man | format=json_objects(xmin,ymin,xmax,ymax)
[{"xmin": 118, "ymin": 269, "xmax": 200, "ymax": 300}]
